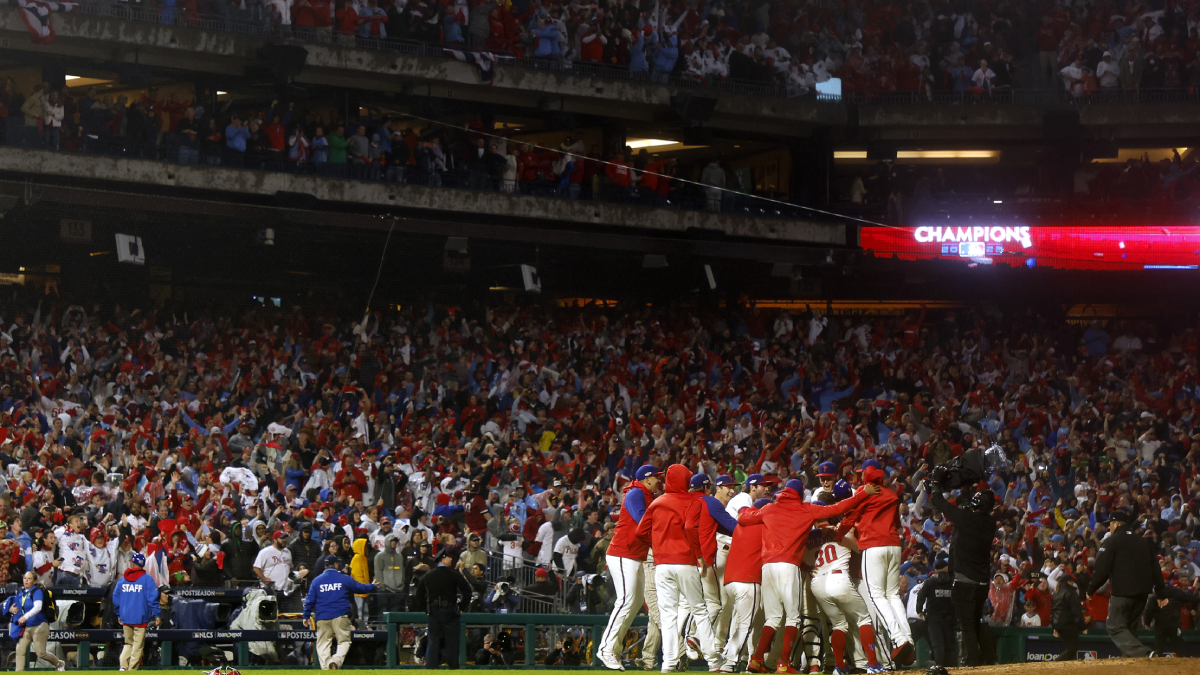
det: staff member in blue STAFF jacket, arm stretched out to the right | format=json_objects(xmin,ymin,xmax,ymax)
[{"xmin": 304, "ymin": 556, "xmax": 376, "ymax": 670}]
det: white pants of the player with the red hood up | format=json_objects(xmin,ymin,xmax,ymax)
[{"xmin": 654, "ymin": 565, "xmax": 718, "ymax": 673}]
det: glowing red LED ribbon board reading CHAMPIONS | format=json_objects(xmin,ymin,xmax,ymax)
[{"xmin": 862, "ymin": 225, "xmax": 1200, "ymax": 270}]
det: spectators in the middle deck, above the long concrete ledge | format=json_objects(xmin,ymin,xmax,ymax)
[{"xmin": 0, "ymin": 78, "xmax": 758, "ymax": 210}]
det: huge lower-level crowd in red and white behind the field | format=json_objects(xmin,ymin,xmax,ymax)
[{"xmin": 0, "ymin": 293, "xmax": 1200, "ymax": 658}]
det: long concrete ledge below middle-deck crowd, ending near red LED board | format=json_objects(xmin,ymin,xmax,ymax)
[{"xmin": 0, "ymin": 147, "xmax": 847, "ymax": 245}]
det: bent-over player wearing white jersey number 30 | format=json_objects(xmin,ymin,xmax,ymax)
[{"xmin": 808, "ymin": 480, "xmax": 886, "ymax": 675}]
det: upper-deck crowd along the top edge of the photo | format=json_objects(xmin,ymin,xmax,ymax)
[{"xmin": 88, "ymin": 0, "xmax": 1200, "ymax": 96}]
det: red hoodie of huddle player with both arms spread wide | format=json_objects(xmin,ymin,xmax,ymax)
[{"xmin": 734, "ymin": 480, "xmax": 866, "ymax": 567}]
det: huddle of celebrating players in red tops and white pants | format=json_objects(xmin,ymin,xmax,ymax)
[{"xmin": 598, "ymin": 460, "xmax": 945, "ymax": 675}]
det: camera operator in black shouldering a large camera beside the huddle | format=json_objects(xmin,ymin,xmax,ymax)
[{"xmin": 930, "ymin": 483, "xmax": 996, "ymax": 665}]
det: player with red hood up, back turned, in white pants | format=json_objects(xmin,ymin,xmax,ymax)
[{"xmin": 637, "ymin": 464, "xmax": 722, "ymax": 673}]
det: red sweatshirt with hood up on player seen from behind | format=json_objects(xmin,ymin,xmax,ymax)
[{"xmin": 637, "ymin": 464, "xmax": 704, "ymax": 565}]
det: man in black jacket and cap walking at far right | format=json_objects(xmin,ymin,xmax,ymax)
[{"xmin": 1087, "ymin": 510, "xmax": 1166, "ymax": 657}]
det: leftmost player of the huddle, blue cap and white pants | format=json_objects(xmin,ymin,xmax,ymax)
[{"xmin": 596, "ymin": 464, "xmax": 662, "ymax": 670}]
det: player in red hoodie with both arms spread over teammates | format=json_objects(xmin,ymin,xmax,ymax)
[{"xmin": 738, "ymin": 479, "xmax": 880, "ymax": 674}]
